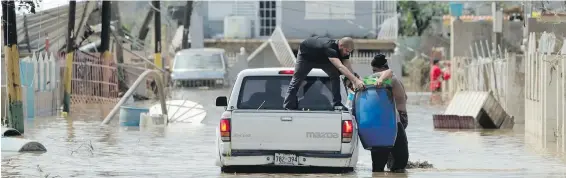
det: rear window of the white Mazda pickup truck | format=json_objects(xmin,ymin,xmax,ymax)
[{"xmin": 237, "ymin": 76, "xmax": 345, "ymax": 110}]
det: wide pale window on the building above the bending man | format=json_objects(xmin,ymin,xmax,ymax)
[{"xmin": 304, "ymin": 0, "xmax": 356, "ymax": 20}]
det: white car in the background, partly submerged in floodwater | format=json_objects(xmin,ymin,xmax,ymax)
[{"xmin": 171, "ymin": 48, "xmax": 228, "ymax": 86}]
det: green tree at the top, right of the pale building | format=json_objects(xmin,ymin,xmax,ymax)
[{"xmin": 397, "ymin": 1, "xmax": 449, "ymax": 36}]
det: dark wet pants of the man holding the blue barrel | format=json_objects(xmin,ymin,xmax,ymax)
[{"xmin": 371, "ymin": 111, "xmax": 409, "ymax": 172}]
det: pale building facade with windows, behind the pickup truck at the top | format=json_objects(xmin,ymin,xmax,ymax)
[{"xmin": 195, "ymin": 0, "xmax": 397, "ymax": 39}]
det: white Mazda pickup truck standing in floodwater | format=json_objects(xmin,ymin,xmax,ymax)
[{"xmin": 216, "ymin": 68, "xmax": 359, "ymax": 172}]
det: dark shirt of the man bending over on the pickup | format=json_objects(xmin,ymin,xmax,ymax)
[{"xmin": 299, "ymin": 36, "xmax": 350, "ymax": 64}]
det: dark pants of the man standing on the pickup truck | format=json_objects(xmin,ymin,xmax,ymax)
[{"xmin": 283, "ymin": 54, "xmax": 342, "ymax": 109}]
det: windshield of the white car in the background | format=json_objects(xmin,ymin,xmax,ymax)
[{"xmin": 173, "ymin": 53, "xmax": 224, "ymax": 69}]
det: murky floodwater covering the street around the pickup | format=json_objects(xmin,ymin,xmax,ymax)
[{"xmin": 2, "ymin": 89, "xmax": 566, "ymax": 178}]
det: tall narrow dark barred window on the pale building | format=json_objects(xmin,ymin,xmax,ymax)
[{"xmin": 259, "ymin": 1, "xmax": 277, "ymax": 36}]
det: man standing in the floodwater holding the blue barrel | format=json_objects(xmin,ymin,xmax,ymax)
[{"xmin": 371, "ymin": 54, "xmax": 409, "ymax": 173}]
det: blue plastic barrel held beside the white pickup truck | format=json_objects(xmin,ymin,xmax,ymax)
[{"xmin": 353, "ymin": 86, "xmax": 397, "ymax": 150}]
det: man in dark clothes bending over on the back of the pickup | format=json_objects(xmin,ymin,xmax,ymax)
[{"xmin": 283, "ymin": 36, "xmax": 392, "ymax": 110}]
